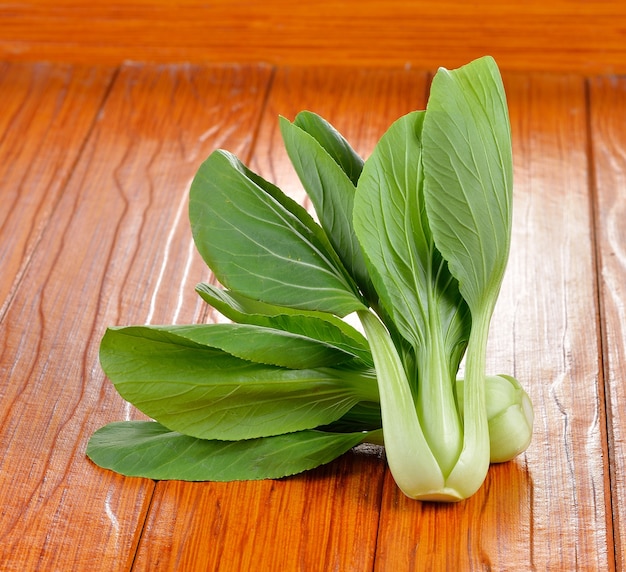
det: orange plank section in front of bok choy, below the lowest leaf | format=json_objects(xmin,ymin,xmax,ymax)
[{"xmin": 134, "ymin": 448, "xmax": 384, "ymax": 572}]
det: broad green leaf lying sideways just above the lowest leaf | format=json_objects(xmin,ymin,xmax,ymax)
[{"xmin": 100, "ymin": 326, "xmax": 378, "ymax": 440}]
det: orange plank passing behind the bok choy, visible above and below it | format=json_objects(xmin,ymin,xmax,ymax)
[{"xmin": 130, "ymin": 69, "xmax": 426, "ymax": 571}]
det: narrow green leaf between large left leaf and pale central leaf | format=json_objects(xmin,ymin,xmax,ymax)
[{"xmin": 280, "ymin": 117, "xmax": 374, "ymax": 304}]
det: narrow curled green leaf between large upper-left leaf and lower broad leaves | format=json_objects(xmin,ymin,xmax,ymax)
[{"xmin": 196, "ymin": 283, "xmax": 373, "ymax": 367}]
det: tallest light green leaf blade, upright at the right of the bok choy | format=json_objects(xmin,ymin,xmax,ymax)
[{"xmin": 423, "ymin": 57, "xmax": 513, "ymax": 313}]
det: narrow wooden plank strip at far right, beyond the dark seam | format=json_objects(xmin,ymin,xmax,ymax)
[{"xmin": 590, "ymin": 77, "xmax": 626, "ymax": 570}]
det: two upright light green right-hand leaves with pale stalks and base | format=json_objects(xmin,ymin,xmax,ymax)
[{"xmin": 354, "ymin": 54, "xmax": 512, "ymax": 500}]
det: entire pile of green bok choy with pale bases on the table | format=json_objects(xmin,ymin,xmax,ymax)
[{"xmin": 87, "ymin": 57, "xmax": 533, "ymax": 501}]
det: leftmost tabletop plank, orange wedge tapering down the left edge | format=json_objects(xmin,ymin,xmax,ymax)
[{"xmin": 0, "ymin": 63, "xmax": 114, "ymax": 319}]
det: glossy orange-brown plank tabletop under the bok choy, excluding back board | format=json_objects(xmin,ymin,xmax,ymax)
[{"xmin": 0, "ymin": 62, "xmax": 626, "ymax": 572}]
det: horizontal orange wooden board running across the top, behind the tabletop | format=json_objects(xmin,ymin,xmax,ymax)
[{"xmin": 0, "ymin": 0, "xmax": 626, "ymax": 73}]
